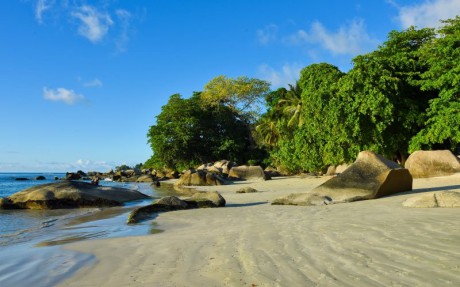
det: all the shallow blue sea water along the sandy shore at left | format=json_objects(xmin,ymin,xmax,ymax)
[{"xmin": 0, "ymin": 173, "xmax": 174, "ymax": 287}]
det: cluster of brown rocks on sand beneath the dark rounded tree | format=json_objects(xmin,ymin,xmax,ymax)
[{"xmin": 174, "ymin": 160, "xmax": 271, "ymax": 186}]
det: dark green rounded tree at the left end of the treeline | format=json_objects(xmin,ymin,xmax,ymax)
[{"xmin": 146, "ymin": 93, "xmax": 249, "ymax": 169}]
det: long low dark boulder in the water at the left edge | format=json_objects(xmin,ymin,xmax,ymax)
[{"xmin": 0, "ymin": 181, "xmax": 149, "ymax": 209}]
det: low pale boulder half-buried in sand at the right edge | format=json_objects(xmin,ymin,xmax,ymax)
[{"xmin": 403, "ymin": 190, "xmax": 460, "ymax": 207}]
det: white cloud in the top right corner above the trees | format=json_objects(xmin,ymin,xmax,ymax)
[{"xmin": 396, "ymin": 0, "xmax": 460, "ymax": 28}]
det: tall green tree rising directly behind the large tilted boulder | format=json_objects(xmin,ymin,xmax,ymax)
[{"xmin": 339, "ymin": 27, "xmax": 434, "ymax": 163}]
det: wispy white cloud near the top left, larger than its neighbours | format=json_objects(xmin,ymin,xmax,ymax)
[{"xmin": 71, "ymin": 5, "xmax": 113, "ymax": 43}]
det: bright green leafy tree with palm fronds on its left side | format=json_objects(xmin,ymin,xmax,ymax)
[{"xmin": 264, "ymin": 63, "xmax": 343, "ymax": 173}]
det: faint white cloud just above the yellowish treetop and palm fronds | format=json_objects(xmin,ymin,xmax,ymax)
[{"xmin": 258, "ymin": 64, "xmax": 302, "ymax": 87}]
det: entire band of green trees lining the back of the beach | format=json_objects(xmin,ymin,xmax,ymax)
[{"xmin": 148, "ymin": 16, "xmax": 460, "ymax": 172}]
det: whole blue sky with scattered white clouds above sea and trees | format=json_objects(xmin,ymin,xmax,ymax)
[{"xmin": 0, "ymin": 0, "xmax": 460, "ymax": 172}]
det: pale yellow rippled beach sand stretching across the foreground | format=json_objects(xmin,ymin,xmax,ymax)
[{"xmin": 61, "ymin": 174, "xmax": 460, "ymax": 286}]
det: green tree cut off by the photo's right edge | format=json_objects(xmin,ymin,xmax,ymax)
[{"xmin": 410, "ymin": 16, "xmax": 460, "ymax": 152}]
